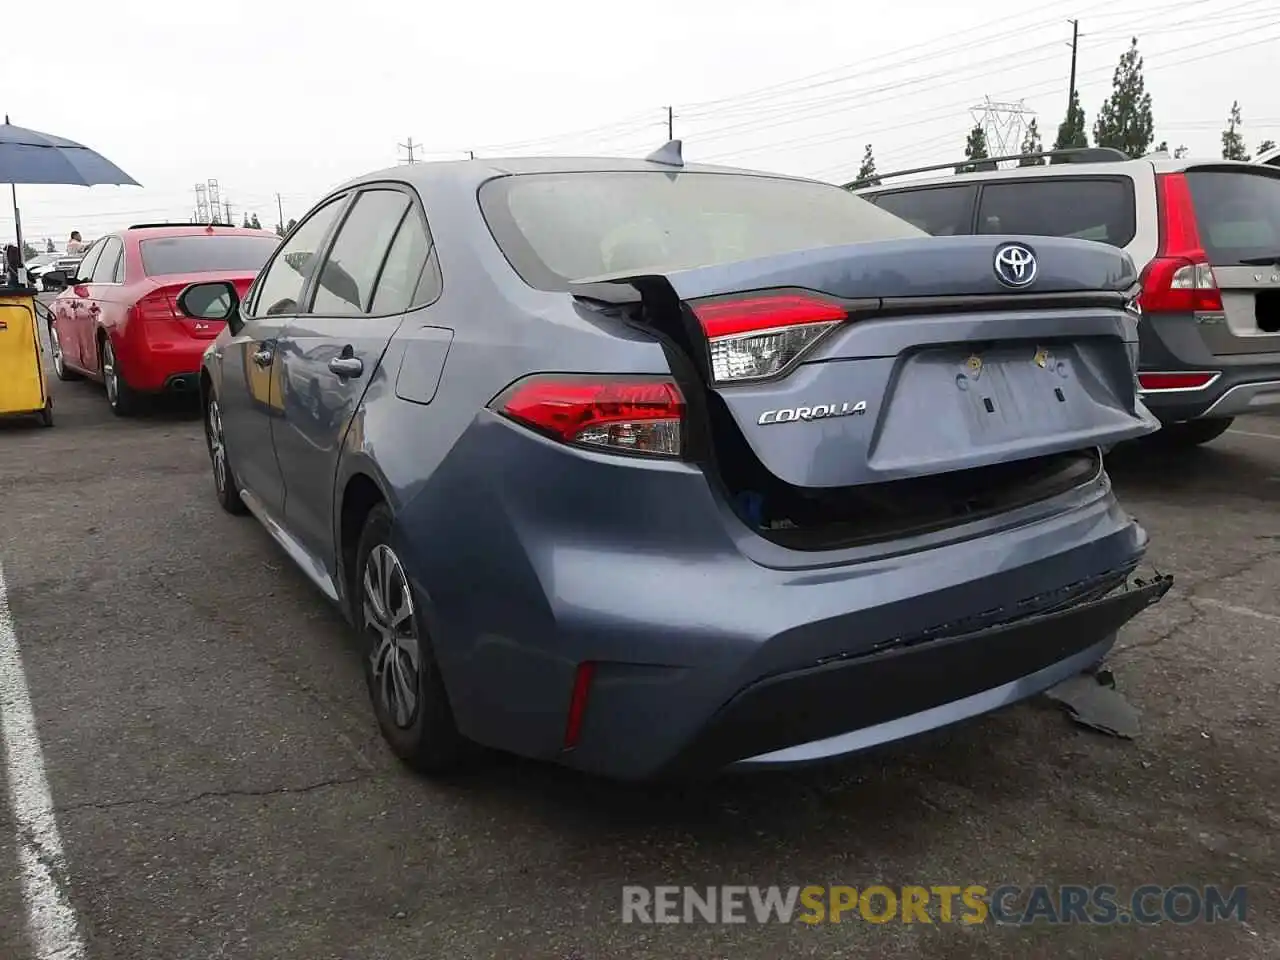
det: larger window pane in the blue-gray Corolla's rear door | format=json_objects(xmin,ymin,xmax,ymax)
[{"xmin": 310, "ymin": 189, "xmax": 410, "ymax": 316}]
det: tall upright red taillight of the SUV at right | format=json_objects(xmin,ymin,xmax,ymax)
[{"xmin": 1139, "ymin": 173, "xmax": 1222, "ymax": 314}]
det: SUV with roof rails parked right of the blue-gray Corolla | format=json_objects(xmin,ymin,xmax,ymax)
[{"xmin": 845, "ymin": 150, "xmax": 1280, "ymax": 444}]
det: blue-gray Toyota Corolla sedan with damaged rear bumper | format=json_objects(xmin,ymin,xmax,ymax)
[{"xmin": 179, "ymin": 143, "xmax": 1169, "ymax": 778}]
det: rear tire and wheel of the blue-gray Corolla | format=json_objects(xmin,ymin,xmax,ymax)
[{"xmin": 351, "ymin": 503, "xmax": 470, "ymax": 776}]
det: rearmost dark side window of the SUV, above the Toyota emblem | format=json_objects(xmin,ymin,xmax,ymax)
[{"xmin": 978, "ymin": 177, "xmax": 1137, "ymax": 247}]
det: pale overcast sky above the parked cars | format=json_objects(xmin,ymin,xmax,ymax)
[{"xmin": 0, "ymin": 0, "xmax": 1280, "ymax": 246}]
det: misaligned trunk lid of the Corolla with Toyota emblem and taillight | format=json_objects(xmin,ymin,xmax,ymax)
[{"xmin": 573, "ymin": 236, "xmax": 1157, "ymax": 488}]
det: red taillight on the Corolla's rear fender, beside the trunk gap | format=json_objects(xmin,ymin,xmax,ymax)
[{"xmin": 490, "ymin": 374, "xmax": 685, "ymax": 457}]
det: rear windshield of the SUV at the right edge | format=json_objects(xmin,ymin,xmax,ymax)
[{"xmin": 1187, "ymin": 170, "xmax": 1280, "ymax": 266}]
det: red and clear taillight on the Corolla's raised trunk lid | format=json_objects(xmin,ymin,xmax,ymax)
[{"xmin": 692, "ymin": 293, "xmax": 849, "ymax": 383}]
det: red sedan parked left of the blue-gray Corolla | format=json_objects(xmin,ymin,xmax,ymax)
[{"xmin": 49, "ymin": 224, "xmax": 280, "ymax": 416}]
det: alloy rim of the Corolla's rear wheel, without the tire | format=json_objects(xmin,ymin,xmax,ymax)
[{"xmin": 362, "ymin": 544, "xmax": 422, "ymax": 730}]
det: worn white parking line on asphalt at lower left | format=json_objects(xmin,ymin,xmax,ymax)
[{"xmin": 0, "ymin": 567, "xmax": 84, "ymax": 960}]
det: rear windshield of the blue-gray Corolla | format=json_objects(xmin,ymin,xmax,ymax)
[{"xmin": 480, "ymin": 172, "xmax": 924, "ymax": 291}]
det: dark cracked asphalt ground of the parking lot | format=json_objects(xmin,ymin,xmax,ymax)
[{"xmin": 0, "ymin": 317, "xmax": 1280, "ymax": 960}]
